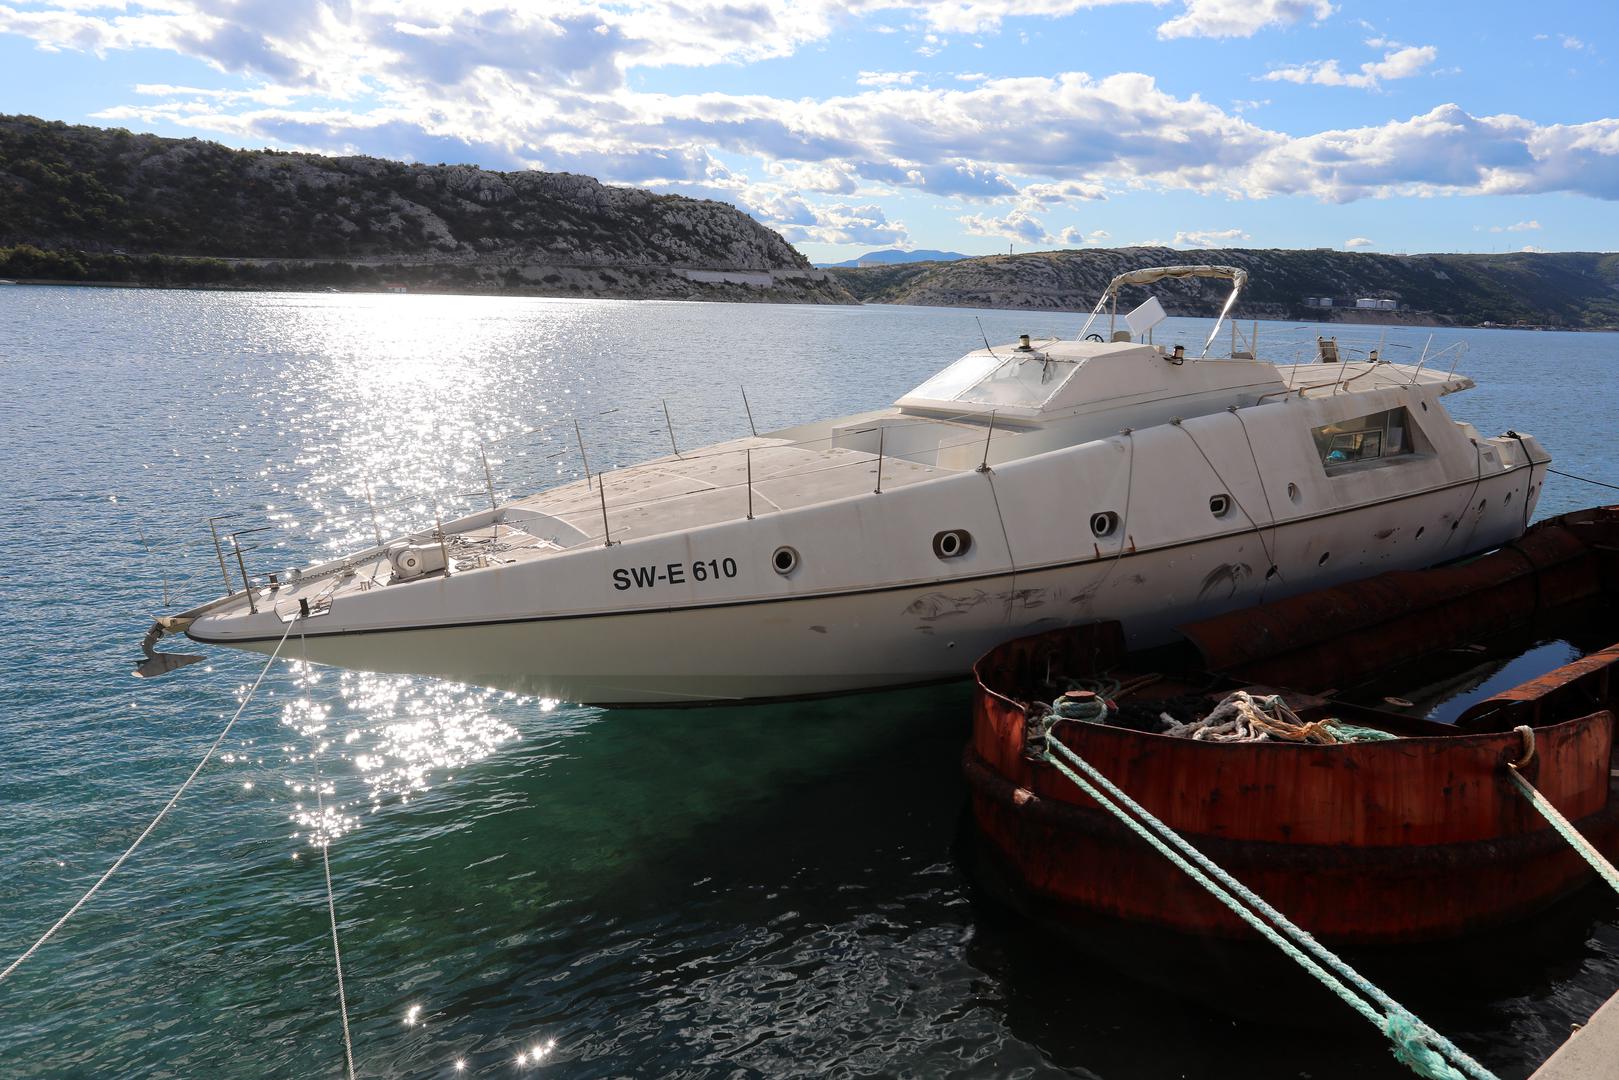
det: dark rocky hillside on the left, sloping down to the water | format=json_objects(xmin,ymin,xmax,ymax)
[{"xmin": 0, "ymin": 115, "xmax": 850, "ymax": 303}]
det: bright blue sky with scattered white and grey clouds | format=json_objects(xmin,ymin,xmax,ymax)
[{"xmin": 0, "ymin": 0, "xmax": 1619, "ymax": 261}]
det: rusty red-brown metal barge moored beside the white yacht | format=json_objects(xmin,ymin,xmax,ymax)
[{"xmin": 963, "ymin": 507, "xmax": 1619, "ymax": 946}]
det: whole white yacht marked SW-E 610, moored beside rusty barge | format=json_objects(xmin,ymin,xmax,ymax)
[{"xmin": 139, "ymin": 266, "xmax": 1551, "ymax": 704}]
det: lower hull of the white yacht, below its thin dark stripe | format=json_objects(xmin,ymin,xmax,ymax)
[{"xmin": 208, "ymin": 470, "xmax": 1530, "ymax": 706}]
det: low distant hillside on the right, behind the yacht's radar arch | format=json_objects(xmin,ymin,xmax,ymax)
[{"xmin": 832, "ymin": 248, "xmax": 1619, "ymax": 329}]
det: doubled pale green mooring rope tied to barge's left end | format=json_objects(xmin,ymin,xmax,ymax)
[{"xmin": 1044, "ymin": 729, "xmax": 1498, "ymax": 1080}]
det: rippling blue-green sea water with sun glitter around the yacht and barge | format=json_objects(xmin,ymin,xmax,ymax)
[{"xmin": 0, "ymin": 288, "xmax": 1619, "ymax": 1078}]
